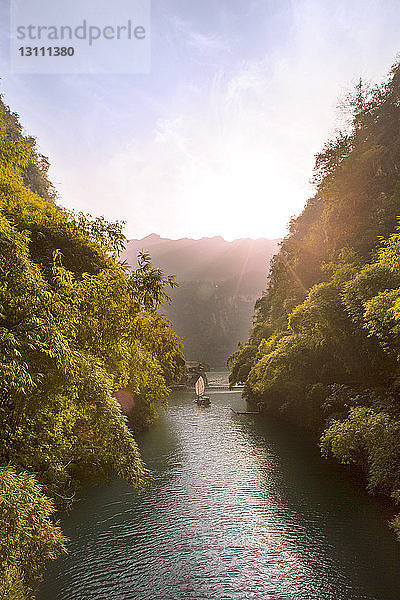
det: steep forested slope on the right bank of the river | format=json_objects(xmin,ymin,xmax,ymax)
[{"xmin": 230, "ymin": 66, "xmax": 400, "ymax": 534}]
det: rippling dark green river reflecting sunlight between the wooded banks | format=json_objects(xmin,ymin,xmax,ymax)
[{"xmin": 40, "ymin": 372, "xmax": 400, "ymax": 600}]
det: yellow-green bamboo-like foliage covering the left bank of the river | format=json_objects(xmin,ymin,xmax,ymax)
[{"xmin": 0, "ymin": 95, "xmax": 184, "ymax": 598}]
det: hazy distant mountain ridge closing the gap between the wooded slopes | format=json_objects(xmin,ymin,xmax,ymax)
[{"xmin": 122, "ymin": 233, "xmax": 280, "ymax": 366}]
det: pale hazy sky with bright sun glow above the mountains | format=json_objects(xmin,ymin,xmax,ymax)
[{"xmin": 0, "ymin": 0, "xmax": 400, "ymax": 239}]
